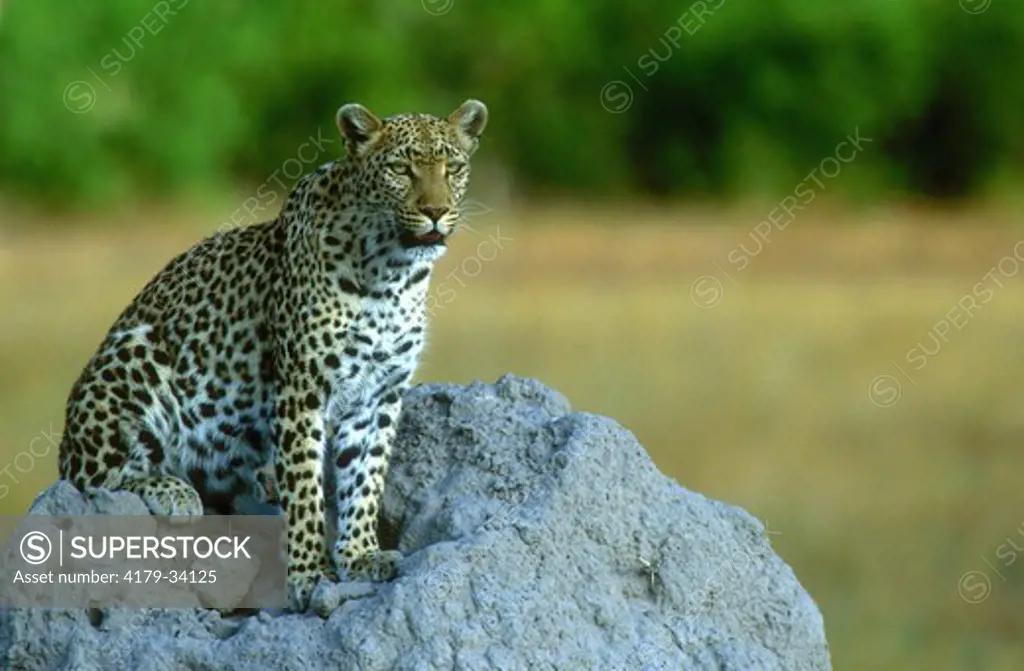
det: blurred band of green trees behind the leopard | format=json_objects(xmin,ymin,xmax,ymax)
[{"xmin": 0, "ymin": 0, "xmax": 1024, "ymax": 207}]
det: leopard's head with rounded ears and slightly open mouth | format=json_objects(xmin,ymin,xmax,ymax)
[{"xmin": 337, "ymin": 100, "xmax": 487, "ymax": 247}]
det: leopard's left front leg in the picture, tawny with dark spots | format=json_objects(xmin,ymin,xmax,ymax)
[{"xmin": 274, "ymin": 386, "xmax": 327, "ymax": 611}]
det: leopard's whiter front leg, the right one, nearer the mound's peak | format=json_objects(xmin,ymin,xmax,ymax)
[{"xmin": 332, "ymin": 389, "xmax": 401, "ymax": 581}]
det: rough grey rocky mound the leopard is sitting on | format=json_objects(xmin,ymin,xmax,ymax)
[{"xmin": 0, "ymin": 376, "xmax": 830, "ymax": 671}]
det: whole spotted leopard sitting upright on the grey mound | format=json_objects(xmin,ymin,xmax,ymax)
[{"xmin": 58, "ymin": 99, "xmax": 488, "ymax": 611}]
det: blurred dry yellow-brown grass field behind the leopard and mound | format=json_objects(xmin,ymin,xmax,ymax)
[{"xmin": 0, "ymin": 204, "xmax": 1024, "ymax": 669}]
